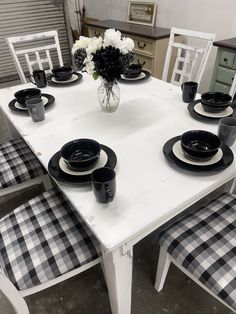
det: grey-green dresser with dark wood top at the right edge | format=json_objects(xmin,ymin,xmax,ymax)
[{"xmin": 211, "ymin": 38, "xmax": 236, "ymax": 94}]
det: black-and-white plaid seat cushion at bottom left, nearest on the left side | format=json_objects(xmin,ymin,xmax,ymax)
[{"xmin": 0, "ymin": 189, "xmax": 100, "ymax": 290}]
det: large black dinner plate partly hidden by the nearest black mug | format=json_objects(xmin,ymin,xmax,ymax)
[{"xmin": 48, "ymin": 145, "xmax": 117, "ymax": 185}]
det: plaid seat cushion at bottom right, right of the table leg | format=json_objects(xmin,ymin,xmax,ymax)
[{"xmin": 160, "ymin": 193, "xmax": 236, "ymax": 310}]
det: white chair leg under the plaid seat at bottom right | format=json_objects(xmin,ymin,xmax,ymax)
[{"xmin": 155, "ymin": 247, "xmax": 171, "ymax": 292}]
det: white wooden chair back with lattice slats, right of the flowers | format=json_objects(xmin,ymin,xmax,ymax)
[{"xmin": 162, "ymin": 28, "xmax": 215, "ymax": 86}]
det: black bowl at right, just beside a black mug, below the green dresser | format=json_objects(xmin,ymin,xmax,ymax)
[{"xmin": 201, "ymin": 92, "xmax": 232, "ymax": 112}]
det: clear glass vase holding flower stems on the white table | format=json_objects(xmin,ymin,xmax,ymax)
[{"xmin": 98, "ymin": 79, "xmax": 120, "ymax": 112}]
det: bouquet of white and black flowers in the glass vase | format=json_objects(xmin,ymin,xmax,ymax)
[{"xmin": 72, "ymin": 29, "xmax": 134, "ymax": 83}]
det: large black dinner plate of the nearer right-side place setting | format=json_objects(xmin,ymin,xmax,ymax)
[{"xmin": 163, "ymin": 136, "xmax": 234, "ymax": 172}]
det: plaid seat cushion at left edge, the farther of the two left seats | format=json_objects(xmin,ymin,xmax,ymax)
[{"xmin": 0, "ymin": 139, "xmax": 44, "ymax": 188}]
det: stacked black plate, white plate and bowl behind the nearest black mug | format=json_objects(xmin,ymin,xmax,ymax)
[{"xmin": 48, "ymin": 138, "xmax": 117, "ymax": 185}]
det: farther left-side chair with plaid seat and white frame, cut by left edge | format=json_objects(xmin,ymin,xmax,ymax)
[{"xmin": 0, "ymin": 138, "xmax": 51, "ymax": 196}]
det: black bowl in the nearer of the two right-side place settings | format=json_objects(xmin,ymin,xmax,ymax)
[{"xmin": 180, "ymin": 130, "xmax": 221, "ymax": 160}]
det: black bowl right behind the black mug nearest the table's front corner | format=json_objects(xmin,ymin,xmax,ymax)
[{"xmin": 61, "ymin": 138, "xmax": 101, "ymax": 171}]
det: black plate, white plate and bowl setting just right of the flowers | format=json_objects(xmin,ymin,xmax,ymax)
[{"xmin": 119, "ymin": 63, "xmax": 151, "ymax": 83}]
